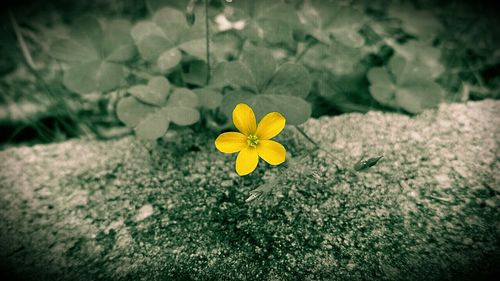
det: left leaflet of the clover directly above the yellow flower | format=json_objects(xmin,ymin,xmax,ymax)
[{"xmin": 210, "ymin": 61, "xmax": 257, "ymax": 92}]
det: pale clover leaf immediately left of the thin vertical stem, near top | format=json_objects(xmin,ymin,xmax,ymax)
[{"xmin": 131, "ymin": 7, "xmax": 206, "ymax": 73}]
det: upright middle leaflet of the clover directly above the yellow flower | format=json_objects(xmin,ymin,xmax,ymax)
[{"xmin": 241, "ymin": 48, "xmax": 276, "ymax": 90}]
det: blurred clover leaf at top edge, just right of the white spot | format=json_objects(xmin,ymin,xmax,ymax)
[{"xmin": 224, "ymin": 0, "xmax": 300, "ymax": 48}]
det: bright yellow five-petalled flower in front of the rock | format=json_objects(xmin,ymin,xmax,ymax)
[{"xmin": 215, "ymin": 103, "xmax": 286, "ymax": 176}]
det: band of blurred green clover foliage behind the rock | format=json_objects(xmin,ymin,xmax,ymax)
[{"xmin": 0, "ymin": 0, "xmax": 500, "ymax": 144}]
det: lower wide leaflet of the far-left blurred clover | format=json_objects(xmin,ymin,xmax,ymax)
[{"xmin": 63, "ymin": 61, "xmax": 125, "ymax": 93}]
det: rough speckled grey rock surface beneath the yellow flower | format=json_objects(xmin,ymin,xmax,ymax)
[{"xmin": 0, "ymin": 100, "xmax": 500, "ymax": 280}]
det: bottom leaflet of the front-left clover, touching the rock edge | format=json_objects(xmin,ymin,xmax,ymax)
[{"xmin": 134, "ymin": 108, "xmax": 170, "ymax": 140}]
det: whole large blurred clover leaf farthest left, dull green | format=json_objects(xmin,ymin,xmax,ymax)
[{"xmin": 49, "ymin": 16, "xmax": 135, "ymax": 93}]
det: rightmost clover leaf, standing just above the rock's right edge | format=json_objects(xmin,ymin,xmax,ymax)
[{"xmin": 368, "ymin": 56, "xmax": 444, "ymax": 114}]
